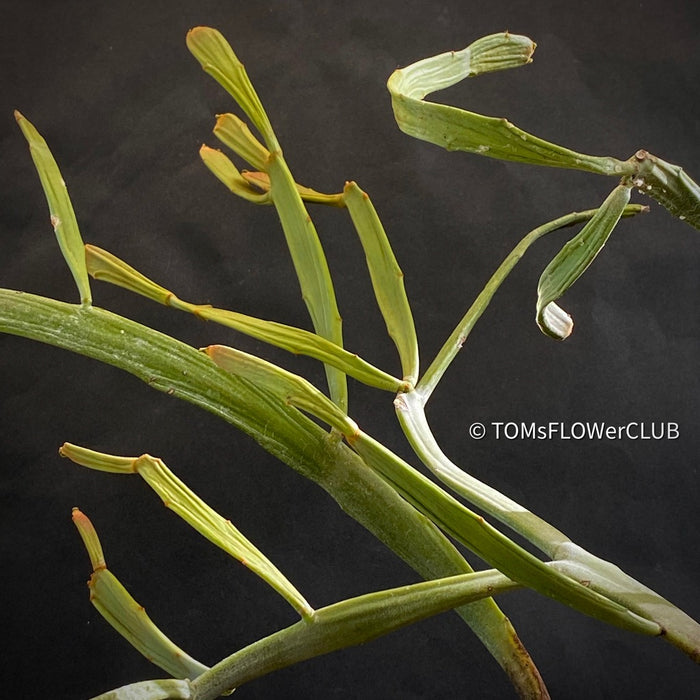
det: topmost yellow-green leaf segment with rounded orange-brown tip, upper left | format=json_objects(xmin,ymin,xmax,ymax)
[{"xmin": 187, "ymin": 27, "xmax": 279, "ymax": 151}]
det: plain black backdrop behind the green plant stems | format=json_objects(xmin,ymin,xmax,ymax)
[{"xmin": 0, "ymin": 0, "xmax": 700, "ymax": 699}]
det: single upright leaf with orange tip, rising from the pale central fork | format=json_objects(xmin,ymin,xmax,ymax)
[{"xmin": 343, "ymin": 182, "xmax": 419, "ymax": 384}]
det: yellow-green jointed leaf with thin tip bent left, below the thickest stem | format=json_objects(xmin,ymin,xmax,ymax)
[{"xmin": 60, "ymin": 443, "xmax": 313, "ymax": 617}]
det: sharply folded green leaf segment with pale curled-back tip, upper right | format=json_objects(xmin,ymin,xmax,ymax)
[{"xmin": 387, "ymin": 32, "xmax": 632, "ymax": 175}]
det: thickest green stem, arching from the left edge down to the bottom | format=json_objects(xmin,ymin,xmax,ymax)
[{"xmin": 0, "ymin": 289, "xmax": 546, "ymax": 698}]
